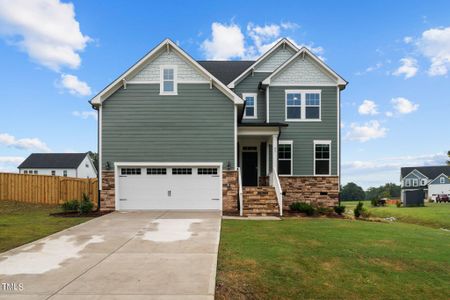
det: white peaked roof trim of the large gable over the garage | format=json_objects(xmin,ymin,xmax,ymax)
[{"xmin": 90, "ymin": 39, "xmax": 244, "ymax": 106}]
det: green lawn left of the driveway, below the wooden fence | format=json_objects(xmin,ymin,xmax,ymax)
[{"xmin": 0, "ymin": 201, "xmax": 92, "ymax": 252}]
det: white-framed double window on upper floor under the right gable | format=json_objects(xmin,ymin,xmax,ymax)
[{"xmin": 286, "ymin": 90, "xmax": 321, "ymax": 121}]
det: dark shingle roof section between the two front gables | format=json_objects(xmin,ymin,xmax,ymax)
[{"xmin": 197, "ymin": 60, "xmax": 254, "ymax": 84}]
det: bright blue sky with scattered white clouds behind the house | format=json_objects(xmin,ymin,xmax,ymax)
[{"xmin": 0, "ymin": 0, "xmax": 450, "ymax": 187}]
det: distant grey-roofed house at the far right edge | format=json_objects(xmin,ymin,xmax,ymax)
[{"xmin": 400, "ymin": 166, "xmax": 450, "ymax": 204}]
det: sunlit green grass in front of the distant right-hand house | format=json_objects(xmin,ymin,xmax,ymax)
[{"xmin": 342, "ymin": 201, "xmax": 450, "ymax": 229}]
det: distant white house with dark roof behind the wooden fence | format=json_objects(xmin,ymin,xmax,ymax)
[{"xmin": 18, "ymin": 153, "xmax": 97, "ymax": 178}]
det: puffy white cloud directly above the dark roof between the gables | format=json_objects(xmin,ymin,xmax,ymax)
[{"xmin": 201, "ymin": 22, "xmax": 245, "ymax": 60}]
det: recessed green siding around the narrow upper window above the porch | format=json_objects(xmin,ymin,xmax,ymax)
[{"xmin": 234, "ymin": 72, "xmax": 270, "ymax": 123}]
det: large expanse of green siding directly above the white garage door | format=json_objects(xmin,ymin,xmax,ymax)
[{"xmin": 102, "ymin": 84, "xmax": 235, "ymax": 168}]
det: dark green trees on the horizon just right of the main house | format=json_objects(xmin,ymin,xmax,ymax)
[{"xmin": 340, "ymin": 182, "xmax": 401, "ymax": 201}]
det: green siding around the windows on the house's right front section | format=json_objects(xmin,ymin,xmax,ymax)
[{"xmin": 269, "ymin": 86, "xmax": 338, "ymax": 176}]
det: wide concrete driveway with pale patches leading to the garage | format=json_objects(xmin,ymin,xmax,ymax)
[{"xmin": 0, "ymin": 211, "xmax": 221, "ymax": 299}]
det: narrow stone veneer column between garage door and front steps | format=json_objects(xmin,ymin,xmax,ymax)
[{"xmin": 222, "ymin": 171, "xmax": 239, "ymax": 214}]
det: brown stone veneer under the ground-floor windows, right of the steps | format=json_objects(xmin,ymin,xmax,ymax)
[{"xmin": 279, "ymin": 176, "xmax": 339, "ymax": 210}]
